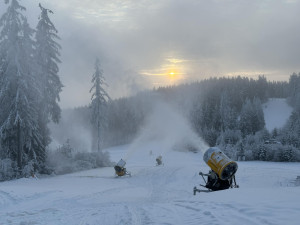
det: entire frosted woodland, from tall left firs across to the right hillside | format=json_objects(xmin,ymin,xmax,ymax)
[{"xmin": 0, "ymin": 0, "xmax": 300, "ymax": 181}]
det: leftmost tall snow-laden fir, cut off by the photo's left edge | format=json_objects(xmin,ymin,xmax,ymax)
[{"xmin": 0, "ymin": 0, "xmax": 45, "ymax": 174}]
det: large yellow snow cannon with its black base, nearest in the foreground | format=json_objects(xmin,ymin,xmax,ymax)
[{"xmin": 194, "ymin": 147, "xmax": 239, "ymax": 195}]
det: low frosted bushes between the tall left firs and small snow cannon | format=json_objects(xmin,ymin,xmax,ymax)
[{"xmin": 46, "ymin": 141, "xmax": 112, "ymax": 174}]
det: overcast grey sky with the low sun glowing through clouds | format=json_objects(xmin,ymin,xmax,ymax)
[{"xmin": 0, "ymin": 0, "xmax": 300, "ymax": 108}]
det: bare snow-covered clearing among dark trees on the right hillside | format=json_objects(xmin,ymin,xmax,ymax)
[{"xmin": 263, "ymin": 98, "xmax": 292, "ymax": 131}]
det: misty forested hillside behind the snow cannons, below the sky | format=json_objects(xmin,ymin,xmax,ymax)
[{"xmin": 59, "ymin": 73, "xmax": 300, "ymax": 162}]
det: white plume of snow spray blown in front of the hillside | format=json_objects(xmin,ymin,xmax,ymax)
[{"xmin": 124, "ymin": 102, "xmax": 208, "ymax": 161}]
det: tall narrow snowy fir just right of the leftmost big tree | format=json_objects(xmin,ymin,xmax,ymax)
[{"xmin": 35, "ymin": 4, "xmax": 63, "ymax": 146}]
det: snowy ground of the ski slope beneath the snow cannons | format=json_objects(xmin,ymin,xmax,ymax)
[{"xmin": 0, "ymin": 145, "xmax": 300, "ymax": 225}]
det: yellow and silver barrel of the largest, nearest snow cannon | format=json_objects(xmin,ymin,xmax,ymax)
[{"xmin": 203, "ymin": 147, "xmax": 238, "ymax": 180}]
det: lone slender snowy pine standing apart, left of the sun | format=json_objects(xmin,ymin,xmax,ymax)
[{"xmin": 90, "ymin": 58, "xmax": 110, "ymax": 151}]
